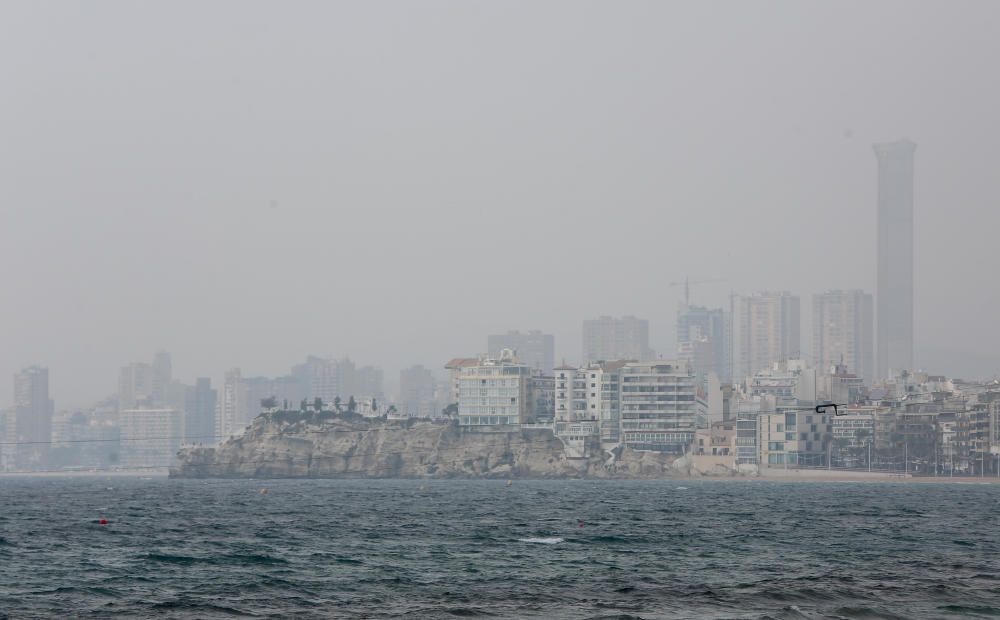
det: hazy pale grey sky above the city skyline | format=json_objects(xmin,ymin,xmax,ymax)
[{"xmin": 0, "ymin": 0, "xmax": 1000, "ymax": 407}]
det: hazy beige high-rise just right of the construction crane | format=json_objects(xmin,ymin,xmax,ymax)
[{"xmin": 731, "ymin": 292, "xmax": 801, "ymax": 382}]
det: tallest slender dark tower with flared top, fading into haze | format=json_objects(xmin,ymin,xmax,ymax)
[{"xmin": 875, "ymin": 140, "xmax": 917, "ymax": 379}]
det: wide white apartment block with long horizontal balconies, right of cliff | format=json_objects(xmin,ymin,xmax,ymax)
[{"xmin": 619, "ymin": 360, "xmax": 697, "ymax": 454}]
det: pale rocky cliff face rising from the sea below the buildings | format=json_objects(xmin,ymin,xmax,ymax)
[{"xmin": 170, "ymin": 411, "xmax": 696, "ymax": 478}]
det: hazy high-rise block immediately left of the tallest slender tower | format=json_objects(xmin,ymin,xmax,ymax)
[{"xmin": 813, "ymin": 290, "xmax": 875, "ymax": 384}]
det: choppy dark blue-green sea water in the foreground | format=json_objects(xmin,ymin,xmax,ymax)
[{"xmin": 0, "ymin": 477, "xmax": 1000, "ymax": 618}]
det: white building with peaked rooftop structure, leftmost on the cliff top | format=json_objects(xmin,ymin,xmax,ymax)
[{"xmin": 458, "ymin": 350, "xmax": 534, "ymax": 426}]
